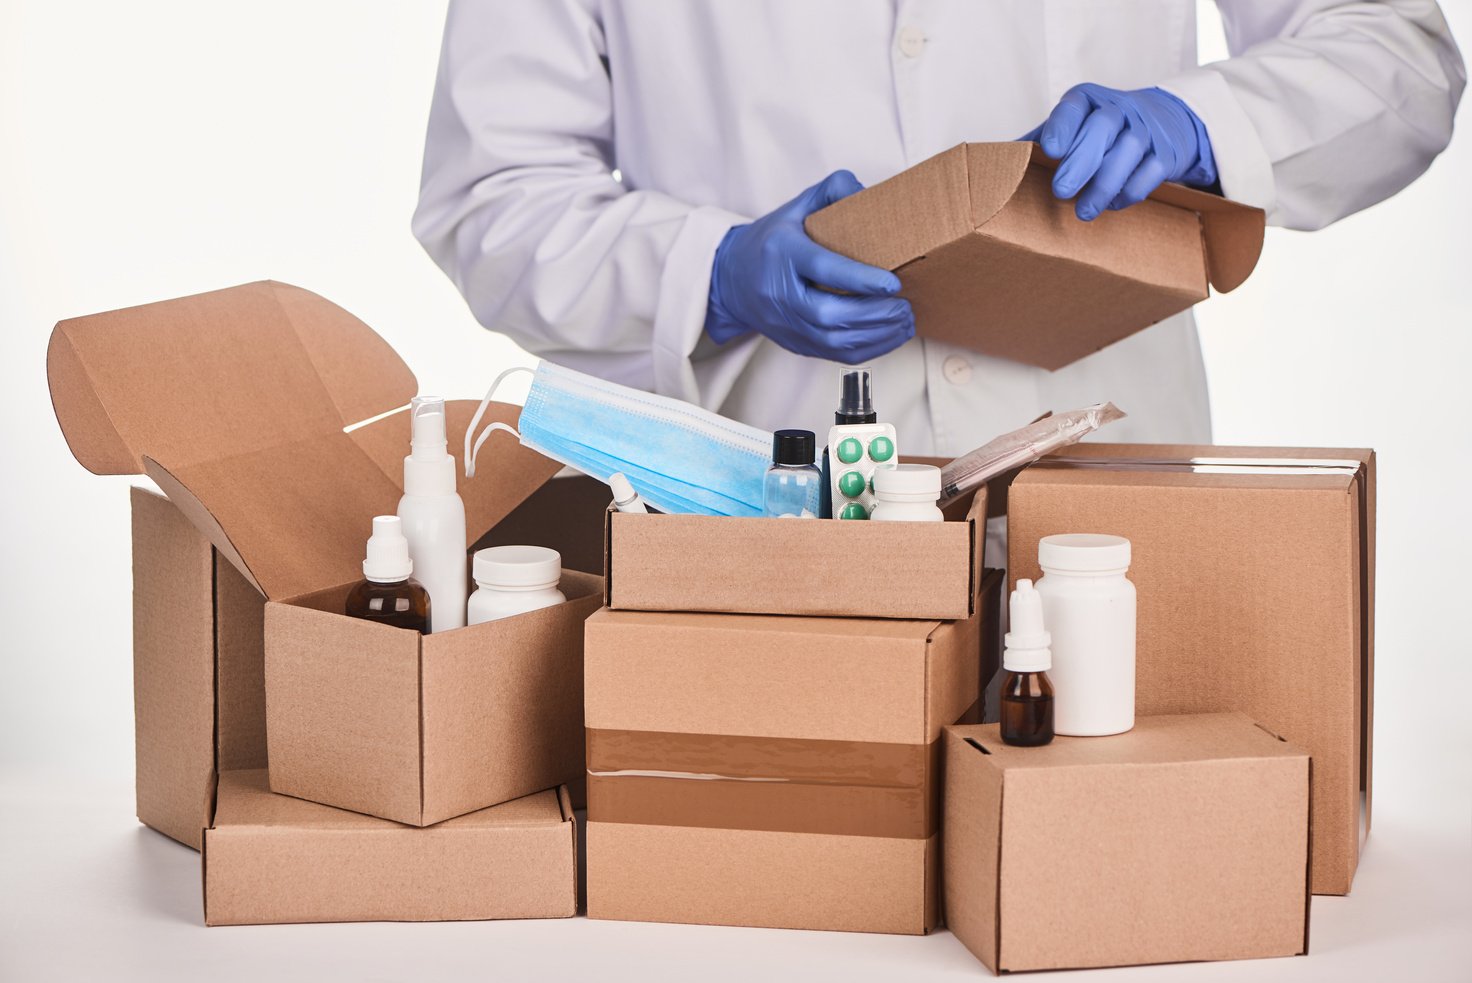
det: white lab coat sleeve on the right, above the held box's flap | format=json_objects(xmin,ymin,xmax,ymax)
[{"xmin": 1160, "ymin": 0, "xmax": 1466, "ymax": 230}]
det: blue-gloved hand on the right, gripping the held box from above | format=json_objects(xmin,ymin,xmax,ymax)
[{"xmin": 1023, "ymin": 82, "xmax": 1216, "ymax": 222}]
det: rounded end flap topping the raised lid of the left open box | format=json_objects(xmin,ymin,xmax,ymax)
[{"xmin": 46, "ymin": 281, "xmax": 417, "ymax": 474}]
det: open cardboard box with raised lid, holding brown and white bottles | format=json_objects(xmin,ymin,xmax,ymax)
[{"xmin": 47, "ymin": 283, "xmax": 602, "ymax": 824}]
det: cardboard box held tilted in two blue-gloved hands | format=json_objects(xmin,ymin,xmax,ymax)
[{"xmin": 807, "ymin": 143, "xmax": 1264, "ymax": 369}]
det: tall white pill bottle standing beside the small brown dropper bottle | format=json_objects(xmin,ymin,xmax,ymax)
[{"xmin": 1036, "ymin": 533, "xmax": 1135, "ymax": 737}]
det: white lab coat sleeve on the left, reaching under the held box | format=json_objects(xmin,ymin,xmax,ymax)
[{"xmin": 414, "ymin": 0, "xmax": 748, "ymax": 402}]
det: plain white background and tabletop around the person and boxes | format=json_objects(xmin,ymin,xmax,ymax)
[{"xmin": 0, "ymin": 0, "xmax": 1472, "ymax": 980}]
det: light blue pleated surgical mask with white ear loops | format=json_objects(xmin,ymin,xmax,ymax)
[{"xmin": 465, "ymin": 361, "xmax": 771, "ymax": 515}]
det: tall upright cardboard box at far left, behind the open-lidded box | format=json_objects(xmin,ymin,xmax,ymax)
[{"xmin": 132, "ymin": 489, "xmax": 266, "ymax": 849}]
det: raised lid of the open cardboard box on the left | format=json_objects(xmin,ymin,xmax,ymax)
[{"xmin": 46, "ymin": 281, "xmax": 558, "ymax": 599}]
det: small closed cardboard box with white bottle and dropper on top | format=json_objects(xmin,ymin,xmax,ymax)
[{"xmin": 945, "ymin": 714, "xmax": 1310, "ymax": 973}]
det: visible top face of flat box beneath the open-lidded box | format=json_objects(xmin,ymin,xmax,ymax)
[{"xmin": 210, "ymin": 768, "xmax": 573, "ymax": 830}]
